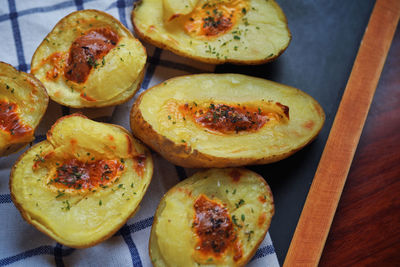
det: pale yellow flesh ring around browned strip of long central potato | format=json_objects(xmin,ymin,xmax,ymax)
[{"xmin": 139, "ymin": 74, "xmax": 323, "ymax": 158}]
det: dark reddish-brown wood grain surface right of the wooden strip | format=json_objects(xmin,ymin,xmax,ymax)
[{"xmin": 320, "ymin": 24, "xmax": 400, "ymax": 267}]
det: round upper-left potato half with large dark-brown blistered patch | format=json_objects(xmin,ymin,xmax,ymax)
[{"xmin": 31, "ymin": 10, "xmax": 147, "ymax": 108}]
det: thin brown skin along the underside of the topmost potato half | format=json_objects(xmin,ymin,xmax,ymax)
[{"xmin": 131, "ymin": 0, "xmax": 292, "ymax": 65}]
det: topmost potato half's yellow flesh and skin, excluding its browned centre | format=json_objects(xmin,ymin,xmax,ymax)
[{"xmin": 132, "ymin": 0, "xmax": 291, "ymax": 65}]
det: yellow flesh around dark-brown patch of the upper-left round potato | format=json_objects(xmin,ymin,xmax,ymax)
[{"xmin": 31, "ymin": 10, "xmax": 146, "ymax": 107}]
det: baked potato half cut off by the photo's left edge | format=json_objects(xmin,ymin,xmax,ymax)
[{"xmin": 0, "ymin": 62, "xmax": 49, "ymax": 157}]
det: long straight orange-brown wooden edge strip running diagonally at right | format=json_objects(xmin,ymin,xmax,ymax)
[{"xmin": 284, "ymin": 0, "xmax": 400, "ymax": 267}]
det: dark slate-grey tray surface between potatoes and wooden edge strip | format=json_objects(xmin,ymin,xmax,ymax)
[{"xmin": 216, "ymin": 0, "xmax": 375, "ymax": 264}]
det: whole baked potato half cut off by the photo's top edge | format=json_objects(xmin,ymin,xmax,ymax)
[{"xmin": 132, "ymin": 0, "xmax": 291, "ymax": 64}]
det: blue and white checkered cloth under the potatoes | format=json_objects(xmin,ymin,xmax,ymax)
[{"xmin": 0, "ymin": 0, "xmax": 279, "ymax": 266}]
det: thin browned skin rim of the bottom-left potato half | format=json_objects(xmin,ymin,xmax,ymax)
[{"xmin": 9, "ymin": 114, "xmax": 154, "ymax": 248}]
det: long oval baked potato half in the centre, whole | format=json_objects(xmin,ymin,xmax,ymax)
[{"xmin": 130, "ymin": 74, "xmax": 325, "ymax": 168}]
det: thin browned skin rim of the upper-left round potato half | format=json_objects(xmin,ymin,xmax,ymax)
[{"xmin": 31, "ymin": 9, "xmax": 147, "ymax": 108}]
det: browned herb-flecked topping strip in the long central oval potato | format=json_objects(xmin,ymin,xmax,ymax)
[{"xmin": 163, "ymin": 99, "xmax": 289, "ymax": 135}]
